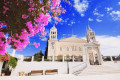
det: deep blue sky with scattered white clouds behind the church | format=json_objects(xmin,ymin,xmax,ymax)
[{"xmin": 7, "ymin": 0, "xmax": 120, "ymax": 56}]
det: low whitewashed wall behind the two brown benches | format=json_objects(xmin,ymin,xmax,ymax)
[{"xmin": 11, "ymin": 61, "xmax": 83, "ymax": 76}]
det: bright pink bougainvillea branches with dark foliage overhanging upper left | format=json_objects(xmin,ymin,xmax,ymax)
[{"xmin": 0, "ymin": 0, "xmax": 65, "ymax": 55}]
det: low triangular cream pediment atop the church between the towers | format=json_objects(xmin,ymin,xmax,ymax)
[{"xmin": 59, "ymin": 36, "xmax": 87, "ymax": 43}]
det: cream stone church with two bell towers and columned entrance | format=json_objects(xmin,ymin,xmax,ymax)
[{"xmin": 47, "ymin": 26, "xmax": 102, "ymax": 65}]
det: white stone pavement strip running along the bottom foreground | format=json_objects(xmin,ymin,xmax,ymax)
[{"xmin": 0, "ymin": 74, "xmax": 120, "ymax": 80}]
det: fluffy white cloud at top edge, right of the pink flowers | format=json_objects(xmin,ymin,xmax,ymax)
[{"xmin": 74, "ymin": 0, "xmax": 89, "ymax": 17}]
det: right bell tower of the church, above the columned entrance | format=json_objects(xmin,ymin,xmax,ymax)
[{"xmin": 86, "ymin": 26, "xmax": 96, "ymax": 43}]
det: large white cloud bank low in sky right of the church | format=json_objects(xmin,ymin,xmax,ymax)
[{"xmin": 96, "ymin": 35, "xmax": 120, "ymax": 56}]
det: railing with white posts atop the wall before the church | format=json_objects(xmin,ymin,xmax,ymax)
[{"xmin": 18, "ymin": 56, "xmax": 83, "ymax": 62}]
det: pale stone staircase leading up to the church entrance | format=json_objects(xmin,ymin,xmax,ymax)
[{"xmin": 75, "ymin": 62, "xmax": 120, "ymax": 76}]
